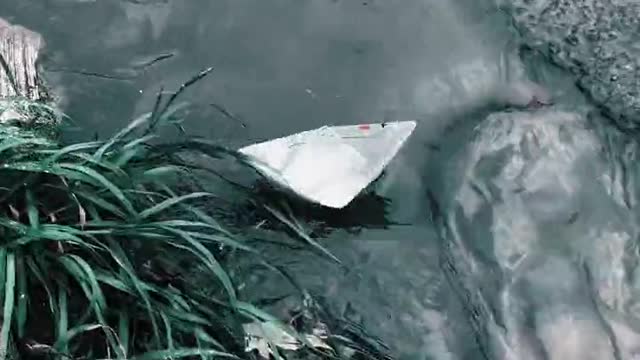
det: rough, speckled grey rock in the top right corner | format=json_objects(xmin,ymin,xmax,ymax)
[{"xmin": 498, "ymin": 0, "xmax": 640, "ymax": 130}]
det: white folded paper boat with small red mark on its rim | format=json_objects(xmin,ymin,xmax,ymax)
[{"xmin": 239, "ymin": 121, "xmax": 416, "ymax": 208}]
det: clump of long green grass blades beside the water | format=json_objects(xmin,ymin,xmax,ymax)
[{"xmin": 0, "ymin": 70, "xmax": 390, "ymax": 360}]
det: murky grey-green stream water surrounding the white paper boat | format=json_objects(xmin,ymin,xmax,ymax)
[{"xmin": 0, "ymin": 0, "xmax": 640, "ymax": 359}]
